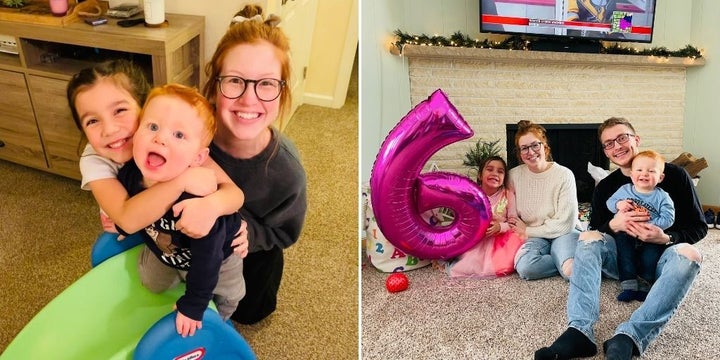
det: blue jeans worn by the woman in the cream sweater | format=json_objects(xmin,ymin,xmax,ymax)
[{"xmin": 515, "ymin": 230, "xmax": 580, "ymax": 280}]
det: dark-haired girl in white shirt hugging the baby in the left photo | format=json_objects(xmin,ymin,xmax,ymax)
[{"xmin": 67, "ymin": 60, "xmax": 247, "ymax": 251}]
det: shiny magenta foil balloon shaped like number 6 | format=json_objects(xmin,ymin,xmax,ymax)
[{"xmin": 370, "ymin": 90, "xmax": 492, "ymax": 259}]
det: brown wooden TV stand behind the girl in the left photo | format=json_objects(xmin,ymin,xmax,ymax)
[{"xmin": 0, "ymin": 14, "xmax": 205, "ymax": 179}]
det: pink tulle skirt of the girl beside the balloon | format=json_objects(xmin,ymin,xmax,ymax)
[{"xmin": 448, "ymin": 231, "xmax": 524, "ymax": 279}]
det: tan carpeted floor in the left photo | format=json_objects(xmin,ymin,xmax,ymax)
[{"xmin": 0, "ymin": 65, "xmax": 358, "ymax": 359}]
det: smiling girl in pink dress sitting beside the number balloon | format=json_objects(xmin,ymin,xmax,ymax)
[{"xmin": 446, "ymin": 156, "xmax": 523, "ymax": 278}]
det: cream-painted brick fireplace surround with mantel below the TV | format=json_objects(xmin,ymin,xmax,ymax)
[{"xmin": 402, "ymin": 45, "xmax": 704, "ymax": 174}]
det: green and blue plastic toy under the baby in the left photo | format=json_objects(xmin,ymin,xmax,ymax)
[{"xmin": 0, "ymin": 234, "xmax": 256, "ymax": 360}]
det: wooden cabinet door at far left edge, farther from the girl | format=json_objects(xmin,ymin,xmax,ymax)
[{"xmin": 0, "ymin": 70, "xmax": 47, "ymax": 170}]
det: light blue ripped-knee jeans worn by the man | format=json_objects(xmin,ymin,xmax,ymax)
[{"xmin": 567, "ymin": 234, "xmax": 700, "ymax": 354}]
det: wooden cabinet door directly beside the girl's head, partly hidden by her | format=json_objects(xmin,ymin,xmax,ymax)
[{"xmin": 28, "ymin": 75, "xmax": 84, "ymax": 179}]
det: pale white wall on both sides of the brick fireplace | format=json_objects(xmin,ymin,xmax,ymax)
[{"xmin": 360, "ymin": 0, "xmax": 720, "ymax": 205}]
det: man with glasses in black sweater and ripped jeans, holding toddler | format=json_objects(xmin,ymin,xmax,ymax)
[{"xmin": 535, "ymin": 118, "xmax": 708, "ymax": 359}]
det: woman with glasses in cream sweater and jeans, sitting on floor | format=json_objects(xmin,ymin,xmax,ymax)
[{"xmin": 509, "ymin": 120, "xmax": 580, "ymax": 280}]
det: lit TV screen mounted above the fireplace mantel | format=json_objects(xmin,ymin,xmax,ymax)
[{"xmin": 480, "ymin": 0, "xmax": 655, "ymax": 43}]
